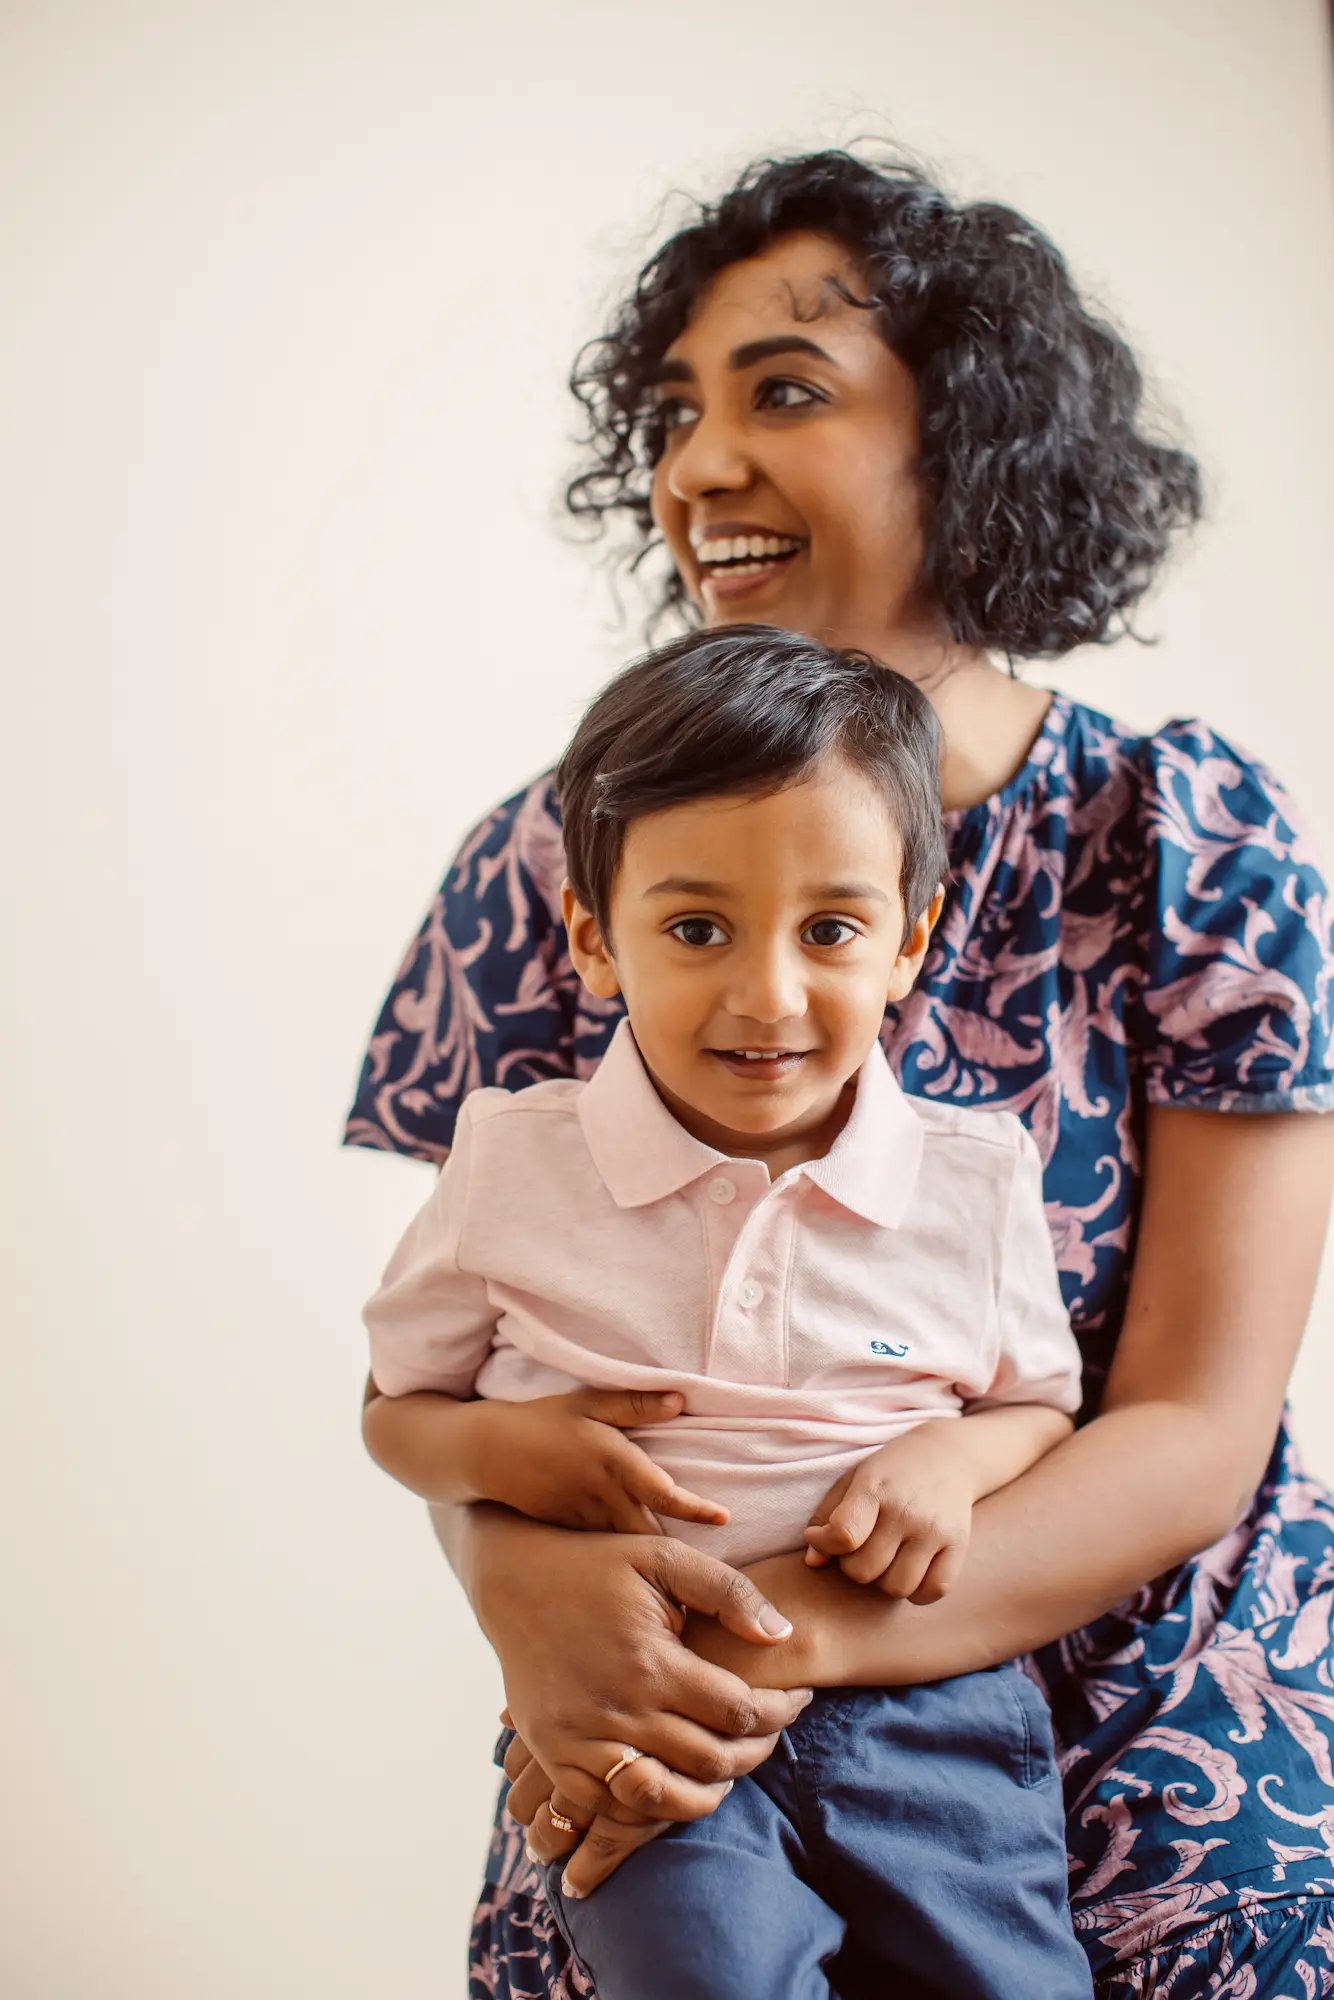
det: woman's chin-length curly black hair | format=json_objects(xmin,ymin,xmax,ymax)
[{"xmin": 566, "ymin": 152, "xmax": 1202, "ymax": 658}]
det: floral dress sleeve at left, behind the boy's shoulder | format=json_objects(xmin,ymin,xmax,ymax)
[{"xmin": 344, "ymin": 776, "xmax": 576, "ymax": 1162}]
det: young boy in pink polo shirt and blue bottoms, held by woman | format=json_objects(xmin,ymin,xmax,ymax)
[{"xmin": 366, "ymin": 626, "xmax": 1092, "ymax": 2000}]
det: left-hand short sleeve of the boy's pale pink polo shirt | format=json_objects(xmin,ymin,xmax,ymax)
[{"xmin": 362, "ymin": 1110, "xmax": 496, "ymax": 1396}]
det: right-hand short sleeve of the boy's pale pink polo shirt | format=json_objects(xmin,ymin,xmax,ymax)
[{"xmin": 966, "ymin": 1114, "xmax": 1082, "ymax": 1416}]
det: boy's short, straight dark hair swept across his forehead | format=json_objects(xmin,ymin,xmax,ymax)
[{"xmin": 556, "ymin": 626, "xmax": 948, "ymax": 938}]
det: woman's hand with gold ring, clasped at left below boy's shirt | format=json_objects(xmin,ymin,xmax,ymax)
[{"xmin": 468, "ymin": 1508, "xmax": 810, "ymax": 1820}]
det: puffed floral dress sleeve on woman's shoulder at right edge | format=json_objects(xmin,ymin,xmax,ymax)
[{"xmin": 1138, "ymin": 722, "xmax": 1334, "ymax": 1112}]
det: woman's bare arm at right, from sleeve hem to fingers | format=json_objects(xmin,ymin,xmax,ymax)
[{"xmin": 688, "ymin": 1108, "xmax": 1334, "ymax": 1686}]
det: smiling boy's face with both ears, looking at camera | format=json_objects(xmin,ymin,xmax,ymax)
[{"xmin": 566, "ymin": 760, "xmax": 940, "ymax": 1164}]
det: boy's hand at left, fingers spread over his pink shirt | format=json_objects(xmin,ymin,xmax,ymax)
[{"xmin": 470, "ymin": 1388, "xmax": 728, "ymax": 1534}]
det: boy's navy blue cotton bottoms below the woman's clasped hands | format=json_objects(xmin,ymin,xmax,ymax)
[{"xmin": 548, "ymin": 1666, "xmax": 1092, "ymax": 2000}]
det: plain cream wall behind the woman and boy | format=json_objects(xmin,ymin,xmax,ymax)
[{"xmin": 0, "ymin": 0, "xmax": 1334, "ymax": 2000}]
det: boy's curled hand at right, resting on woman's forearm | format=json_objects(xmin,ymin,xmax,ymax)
[{"xmin": 806, "ymin": 1422, "xmax": 976, "ymax": 1604}]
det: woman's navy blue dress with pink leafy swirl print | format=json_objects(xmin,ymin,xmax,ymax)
[{"xmin": 348, "ymin": 696, "xmax": 1334, "ymax": 2000}]
